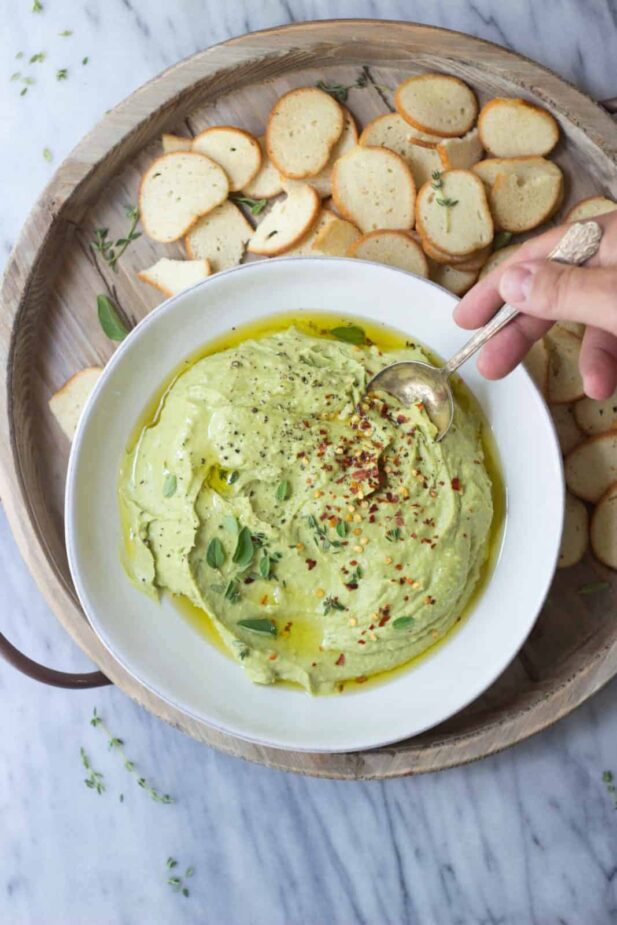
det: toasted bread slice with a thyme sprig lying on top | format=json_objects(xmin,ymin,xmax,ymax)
[{"xmin": 416, "ymin": 170, "xmax": 493, "ymax": 256}]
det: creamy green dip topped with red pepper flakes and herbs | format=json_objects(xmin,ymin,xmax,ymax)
[{"xmin": 119, "ymin": 326, "xmax": 493, "ymax": 694}]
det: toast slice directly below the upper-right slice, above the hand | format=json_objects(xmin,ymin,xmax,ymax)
[{"xmin": 489, "ymin": 173, "xmax": 563, "ymax": 233}]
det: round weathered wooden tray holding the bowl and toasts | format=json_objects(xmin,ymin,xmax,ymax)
[{"xmin": 0, "ymin": 21, "xmax": 617, "ymax": 778}]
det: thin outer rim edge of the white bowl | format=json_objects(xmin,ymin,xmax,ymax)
[{"xmin": 65, "ymin": 255, "xmax": 565, "ymax": 754}]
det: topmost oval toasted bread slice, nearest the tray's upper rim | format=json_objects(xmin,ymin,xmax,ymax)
[{"xmin": 394, "ymin": 74, "xmax": 478, "ymax": 138}]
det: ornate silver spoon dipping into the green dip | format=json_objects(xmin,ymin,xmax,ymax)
[{"xmin": 366, "ymin": 222, "xmax": 602, "ymax": 442}]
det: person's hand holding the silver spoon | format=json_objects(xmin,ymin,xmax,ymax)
[{"xmin": 454, "ymin": 212, "xmax": 617, "ymax": 399}]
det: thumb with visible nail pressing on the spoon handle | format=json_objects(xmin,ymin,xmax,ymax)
[{"xmin": 499, "ymin": 260, "xmax": 617, "ymax": 334}]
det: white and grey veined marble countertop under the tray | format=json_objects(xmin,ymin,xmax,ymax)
[{"xmin": 0, "ymin": 0, "xmax": 617, "ymax": 925}]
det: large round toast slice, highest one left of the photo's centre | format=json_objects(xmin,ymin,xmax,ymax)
[{"xmin": 266, "ymin": 87, "xmax": 345, "ymax": 180}]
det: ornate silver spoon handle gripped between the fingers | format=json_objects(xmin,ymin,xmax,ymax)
[{"xmin": 443, "ymin": 222, "xmax": 602, "ymax": 376}]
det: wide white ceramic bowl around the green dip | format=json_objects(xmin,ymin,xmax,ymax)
[{"xmin": 66, "ymin": 257, "xmax": 564, "ymax": 752}]
